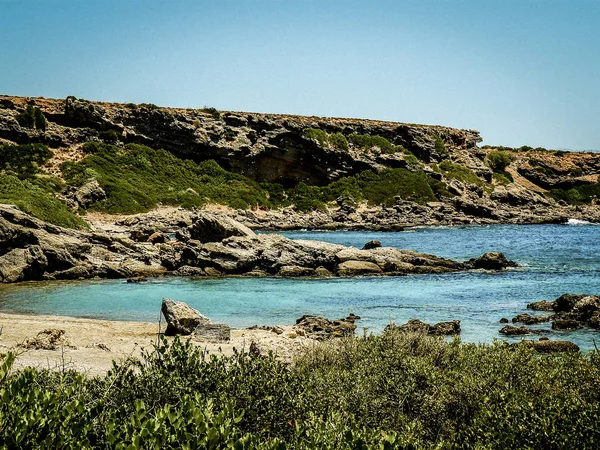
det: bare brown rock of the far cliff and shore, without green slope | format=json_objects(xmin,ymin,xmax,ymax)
[{"xmin": 0, "ymin": 96, "xmax": 600, "ymax": 229}]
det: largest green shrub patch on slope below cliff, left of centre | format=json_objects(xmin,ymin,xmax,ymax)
[{"xmin": 61, "ymin": 143, "xmax": 271, "ymax": 214}]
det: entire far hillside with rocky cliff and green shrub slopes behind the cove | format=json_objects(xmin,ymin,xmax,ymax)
[{"xmin": 0, "ymin": 96, "xmax": 600, "ymax": 229}]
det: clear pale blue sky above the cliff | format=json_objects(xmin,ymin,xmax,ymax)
[{"xmin": 0, "ymin": 0, "xmax": 600, "ymax": 149}]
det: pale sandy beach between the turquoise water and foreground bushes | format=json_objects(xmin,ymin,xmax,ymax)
[{"xmin": 0, "ymin": 313, "xmax": 315, "ymax": 376}]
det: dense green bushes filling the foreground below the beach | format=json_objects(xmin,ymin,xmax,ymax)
[{"xmin": 0, "ymin": 331, "xmax": 600, "ymax": 449}]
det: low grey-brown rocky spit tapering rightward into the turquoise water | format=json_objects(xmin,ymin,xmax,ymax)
[{"xmin": 0, "ymin": 205, "xmax": 516, "ymax": 283}]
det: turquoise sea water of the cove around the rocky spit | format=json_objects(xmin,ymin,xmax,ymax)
[{"xmin": 0, "ymin": 224, "xmax": 600, "ymax": 349}]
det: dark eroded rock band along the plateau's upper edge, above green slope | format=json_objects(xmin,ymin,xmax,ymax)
[{"xmin": 0, "ymin": 96, "xmax": 480, "ymax": 187}]
